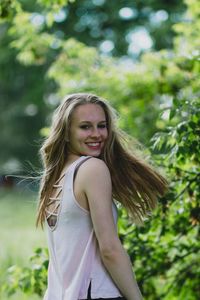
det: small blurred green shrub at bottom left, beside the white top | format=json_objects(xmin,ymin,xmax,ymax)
[{"xmin": 3, "ymin": 248, "xmax": 48, "ymax": 296}]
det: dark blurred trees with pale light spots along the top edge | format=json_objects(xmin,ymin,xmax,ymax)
[{"xmin": 0, "ymin": 0, "xmax": 185, "ymax": 56}]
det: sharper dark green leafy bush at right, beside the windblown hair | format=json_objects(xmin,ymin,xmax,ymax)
[{"xmin": 130, "ymin": 98, "xmax": 200, "ymax": 299}]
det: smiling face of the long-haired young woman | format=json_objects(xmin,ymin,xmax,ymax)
[{"xmin": 69, "ymin": 103, "xmax": 108, "ymax": 157}]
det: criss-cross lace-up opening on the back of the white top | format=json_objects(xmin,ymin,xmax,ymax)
[{"xmin": 45, "ymin": 173, "xmax": 65, "ymax": 230}]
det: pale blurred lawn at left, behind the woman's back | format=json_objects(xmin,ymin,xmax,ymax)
[{"xmin": 0, "ymin": 189, "xmax": 47, "ymax": 300}]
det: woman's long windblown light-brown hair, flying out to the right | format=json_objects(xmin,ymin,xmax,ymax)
[{"xmin": 36, "ymin": 93, "xmax": 167, "ymax": 225}]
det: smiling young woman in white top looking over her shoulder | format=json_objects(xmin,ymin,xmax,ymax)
[{"xmin": 37, "ymin": 94, "xmax": 167, "ymax": 300}]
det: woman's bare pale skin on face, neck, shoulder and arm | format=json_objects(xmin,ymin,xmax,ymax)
[{"xmin": 64, "ymin": 104, "xmax": 142, "ymax": 300}]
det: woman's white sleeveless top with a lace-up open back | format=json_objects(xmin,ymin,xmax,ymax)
[{"xmin": 44, "ymin": 156, "xmax": 121, "ymax": 300}]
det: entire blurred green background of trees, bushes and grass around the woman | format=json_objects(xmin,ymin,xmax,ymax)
[{"xmin": 0, "ymin": 0, "xmax": 200, "ymax": 300}]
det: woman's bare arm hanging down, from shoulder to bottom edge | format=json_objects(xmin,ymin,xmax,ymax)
[{"xmin": 79, "ymin": 158, "xmax": 142, "ymax": 300}]
